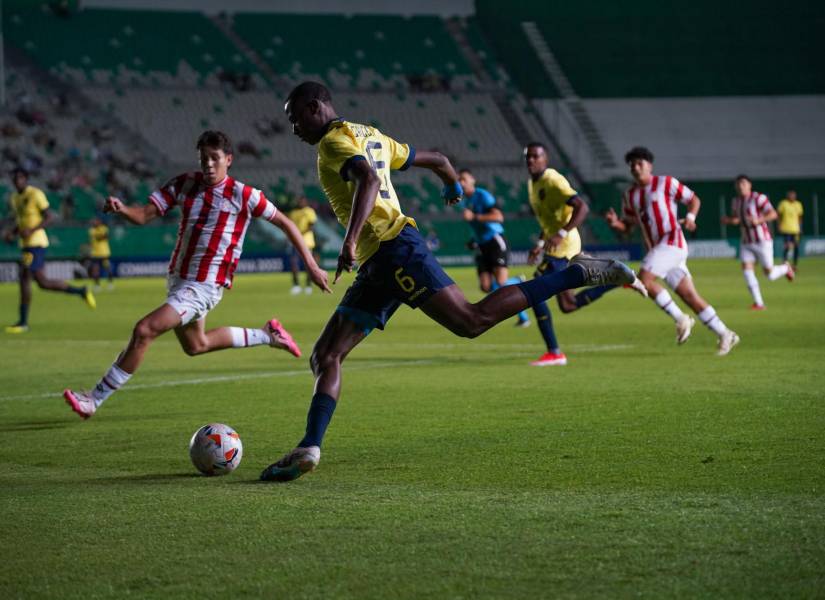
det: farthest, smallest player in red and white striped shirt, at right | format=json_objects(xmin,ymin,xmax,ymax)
[{"xmin": 722, "ymin": 175, "xmax": 794, "ymax": 310}]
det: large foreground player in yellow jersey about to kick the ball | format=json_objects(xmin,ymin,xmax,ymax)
[{"xmin": 261, "ymin": 82, "xmax": 635, "ymax": 481}]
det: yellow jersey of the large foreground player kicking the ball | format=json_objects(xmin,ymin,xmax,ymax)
[{"xmin": 318, "ymin": 120, "xmax": 415, "ymax": 264}]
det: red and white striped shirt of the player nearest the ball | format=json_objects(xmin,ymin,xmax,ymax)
[{"xmin": 149, "ymin": 173, "xmax": 277, "ymax": 288}]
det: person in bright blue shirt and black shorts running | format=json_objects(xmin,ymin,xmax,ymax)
[{"xmin": 458, "ymin": 169, "xmax": 530, "ymax": 327}]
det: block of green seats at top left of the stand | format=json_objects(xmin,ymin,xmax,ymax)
[{"xmin": 4, "ymin": 2, "xmax": 256, "ymax": 85}]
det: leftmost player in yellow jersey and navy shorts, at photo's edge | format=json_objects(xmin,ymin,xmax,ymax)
[{"xmin": 4, "ymin": 167, "xmax": 96, "ymax": 333}]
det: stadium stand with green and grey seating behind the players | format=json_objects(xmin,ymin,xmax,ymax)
[{"xmin": 0, "ymin": 0, "xmax": 825, "ymax": 256}]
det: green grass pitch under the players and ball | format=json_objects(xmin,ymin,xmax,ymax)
[{"xmin": 0, "ymin": 259, "xmax": 825, "ymax": 598}]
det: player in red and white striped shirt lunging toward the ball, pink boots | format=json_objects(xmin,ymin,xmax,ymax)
[{"xmin": 63, "ymin": 131, "xmax": 330, "ymax": 419}]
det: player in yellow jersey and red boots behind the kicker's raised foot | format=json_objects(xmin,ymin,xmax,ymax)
[{"xmin": 524, "ymin": 142, "xmax": 644, "ymax": 367}]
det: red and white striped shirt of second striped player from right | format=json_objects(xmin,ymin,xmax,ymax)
[{"xmin": 622, "ymin": 175, "xmax": 694, "ymax": 248}]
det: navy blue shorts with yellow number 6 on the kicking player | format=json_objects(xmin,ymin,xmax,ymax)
[{"xmin": 336, "ymin": 225, "xmax": 454, "ymax": 333}]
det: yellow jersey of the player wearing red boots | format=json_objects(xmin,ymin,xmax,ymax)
[{"xmin": 527, "ymin": 169, "xmax": 582, "ymax": 258}]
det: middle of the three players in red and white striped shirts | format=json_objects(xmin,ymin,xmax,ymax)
[{"xmin": 606, "ymin": 147, "xmax": 739, "ymax": 356}]
